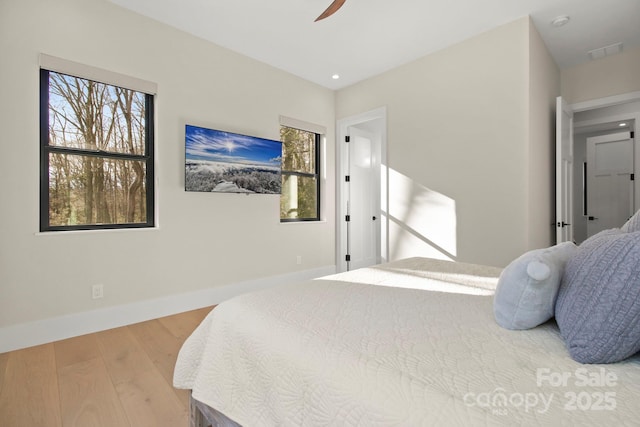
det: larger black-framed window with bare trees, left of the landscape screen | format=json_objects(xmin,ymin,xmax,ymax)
[{"xmin": 40, "ymin": 68, "xmax": 154, "ymax": 231}]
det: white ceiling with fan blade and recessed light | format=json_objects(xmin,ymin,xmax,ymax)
[{"xmin": 110, "ymin": 0, "xmax": 640, "ymax": 89}]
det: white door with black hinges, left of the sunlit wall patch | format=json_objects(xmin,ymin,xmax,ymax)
[{"xmin": 344, "ymin": 126, "xmax": 380, "ymax": 270}]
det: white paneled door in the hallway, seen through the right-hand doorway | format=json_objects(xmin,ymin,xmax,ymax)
[{"xmin": 587, "ymin": 132, "xmax": 635, "ymax": 237}]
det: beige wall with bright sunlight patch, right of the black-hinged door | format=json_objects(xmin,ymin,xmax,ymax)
[{"xmin": 336, "ymin": 17, "xmax": 559, "ymax": 266}]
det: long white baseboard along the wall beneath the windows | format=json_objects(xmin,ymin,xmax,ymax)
[{"xmin": 0, "ymin": 266, "xmax": 336, "ymax": 353}]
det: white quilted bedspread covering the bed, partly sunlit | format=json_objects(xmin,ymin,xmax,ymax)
[{"xmin": 174, "ymin": 258, "xmax": 640, "ymax": 426}]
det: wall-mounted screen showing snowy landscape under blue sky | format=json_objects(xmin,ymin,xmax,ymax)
[{"xmin": 184, "ymin": 125, "xmax": 282, "ymax": 194}]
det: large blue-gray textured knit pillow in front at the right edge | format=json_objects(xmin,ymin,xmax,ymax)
[{"xmin": 555, "ymin": 230, "xmax": 640, "ymax": 363}]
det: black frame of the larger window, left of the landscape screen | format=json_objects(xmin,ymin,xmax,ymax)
[{"xmin": 39, "ymin": 68, "xmax": 156, "ymax": 232}]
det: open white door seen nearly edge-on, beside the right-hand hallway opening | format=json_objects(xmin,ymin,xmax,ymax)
[{"xmin": 556, "ymin": 96, "xmax": 573, "ymax": 243}]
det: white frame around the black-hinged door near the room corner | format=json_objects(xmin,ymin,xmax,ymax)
[{"xmin": 336, "ymin": 107, "xmax": 389, "ymax": 272}]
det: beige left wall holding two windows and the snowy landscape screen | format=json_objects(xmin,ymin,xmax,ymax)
[{"xmin": 0, "ymin": 0, "xmax": 335, "ymax": 328}]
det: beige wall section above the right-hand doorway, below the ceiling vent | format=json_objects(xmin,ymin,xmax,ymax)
[{"xmin": 561, "ymin": 48, "xmax": 640, "ymax": 104}]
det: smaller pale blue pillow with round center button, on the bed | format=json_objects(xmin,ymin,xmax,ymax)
[{"xmin": 493, "ymin": 242, "xmax": 577, "ymax": 329}]
